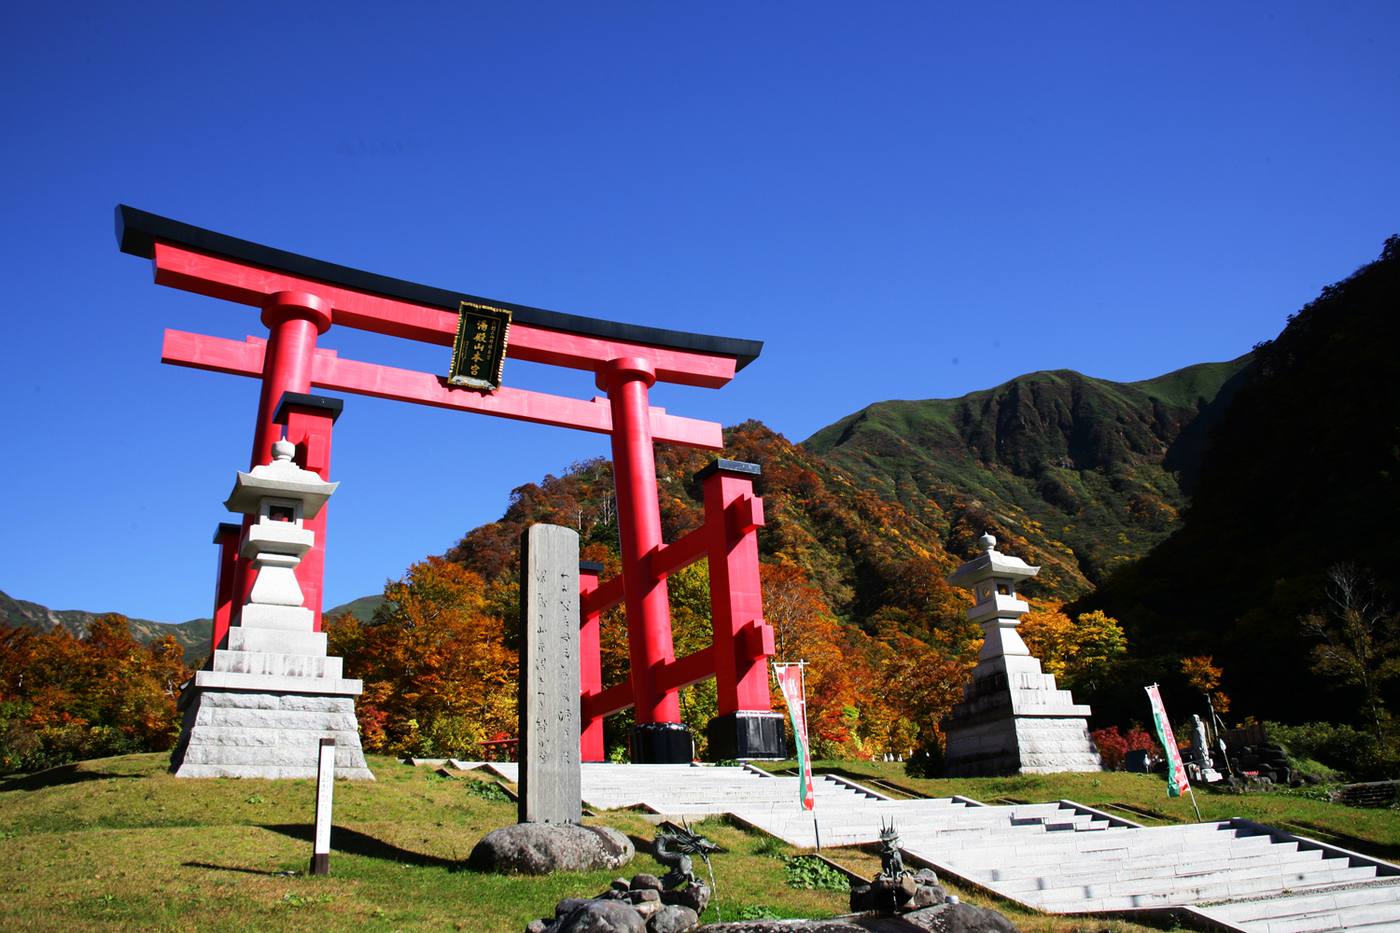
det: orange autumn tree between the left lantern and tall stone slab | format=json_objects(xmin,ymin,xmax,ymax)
[{"xmin": 328, "ymin": 558, "xmax": 518, "ymax": 756}]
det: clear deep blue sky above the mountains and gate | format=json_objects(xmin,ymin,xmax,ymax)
[{"xmin": 0, "ymin": 3, "xmax": 1400, "ymax": 621}]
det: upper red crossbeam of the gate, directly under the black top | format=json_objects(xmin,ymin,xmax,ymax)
[{"xmin": 154, "ymin": 241, "xmax": 736, "ymax": 388}]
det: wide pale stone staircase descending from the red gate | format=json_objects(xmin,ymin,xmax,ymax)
[{"xmin": 473, "ymin": 762, "xmax": 1400, "ymax": 933}]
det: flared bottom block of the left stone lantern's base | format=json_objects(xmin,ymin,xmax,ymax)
[{"xmin": 171, "ymin": 684, "xmax": 374, "ymax": 780}]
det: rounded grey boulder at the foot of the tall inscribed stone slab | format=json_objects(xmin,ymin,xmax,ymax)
[{"xmin": 468, "ymin": 822, "xmax": 636, "ymax": 874}]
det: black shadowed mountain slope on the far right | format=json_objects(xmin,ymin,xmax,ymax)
[{"xmin": 1081, "ymin": 237, "xmax": 1400, "ymax": 720}]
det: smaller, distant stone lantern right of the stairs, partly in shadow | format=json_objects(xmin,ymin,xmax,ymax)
[{"xmin": 944, "ymin": 535, "xmax": 1103, "ymax": 778}]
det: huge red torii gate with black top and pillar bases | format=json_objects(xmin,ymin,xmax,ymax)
[{"xmin": 116, "ymin": 205, "xmax": 785, "ymax": 762}]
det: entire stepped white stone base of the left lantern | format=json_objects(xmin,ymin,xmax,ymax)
[{"xmin": 171, "ymin": 622, "xmax": 374, "ymax": 780}]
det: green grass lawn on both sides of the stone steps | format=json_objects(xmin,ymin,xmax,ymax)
[{"xmin": 0, "ymin": 755, "xmax": 1400, "ymax": 933}]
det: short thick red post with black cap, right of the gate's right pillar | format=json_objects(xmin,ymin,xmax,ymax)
[{"xmin": 699, "ymin": 459, "xmax": 773, "ymax": 716}]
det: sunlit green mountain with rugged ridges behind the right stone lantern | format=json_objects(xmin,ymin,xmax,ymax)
[{"xmin": 802, "ymin": 354, "xmax": 1250, "ymax": 597}]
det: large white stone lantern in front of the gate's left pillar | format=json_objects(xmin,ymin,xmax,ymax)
[{"xmin": 171, "ymin": 440, "xmax": 374, "ymax": 780}]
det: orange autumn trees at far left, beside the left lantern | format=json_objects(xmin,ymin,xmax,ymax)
[{"xmin": 0, "ymin": 614, "xmax": 190, "ymax": 772}]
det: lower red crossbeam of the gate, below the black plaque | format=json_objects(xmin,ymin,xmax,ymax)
[{"xmin": 161, "ymin": 329, "xmax": 724, "ymax": 450}]
